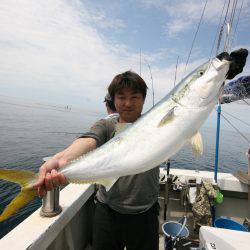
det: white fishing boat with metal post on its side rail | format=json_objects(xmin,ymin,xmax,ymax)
[{"xmin": 0, "ymin": 152, "xmax": 250, "ymax": 250}]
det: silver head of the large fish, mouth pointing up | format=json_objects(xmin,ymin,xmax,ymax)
[{"xmin": 182, "ymin": 57, "xmax": 230, "ymax": 107}]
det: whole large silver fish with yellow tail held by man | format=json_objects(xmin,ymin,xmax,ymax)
[{"xmin": 0, "ymin": 54, "xmax": 229, "ymax": 221}]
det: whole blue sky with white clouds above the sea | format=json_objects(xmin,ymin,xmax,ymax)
[{"xmin": 0, "ymin": 0, "xmax": 250, "ymax": 116}]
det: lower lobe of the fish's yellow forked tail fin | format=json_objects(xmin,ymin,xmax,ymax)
[{"xmin": 0, "ymin": 188, "xmax": 37, "ymax": 221}]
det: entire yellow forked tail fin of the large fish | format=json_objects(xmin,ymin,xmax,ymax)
[{"xmin": 0, "ymin": 169, "xmax": 37, "ymax": 222}]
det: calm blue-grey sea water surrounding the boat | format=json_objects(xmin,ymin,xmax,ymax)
[{"xmin": 0, "ymin": 102, "xmax": 250, "ymax": 238}]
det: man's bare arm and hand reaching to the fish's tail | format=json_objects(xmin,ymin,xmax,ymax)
[{"xmin": 34, "ymin": 138, "xmax": 97, "ymax": 196}]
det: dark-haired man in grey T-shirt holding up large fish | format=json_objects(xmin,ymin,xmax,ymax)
[{"xmin": 36, "ymin": 71, "xmax": 159, "ymax": 250}]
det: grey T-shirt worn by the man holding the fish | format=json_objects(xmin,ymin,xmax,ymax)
[{"xmin": 81, "ymin": 118, "xmax": 159, "ymax": 214}]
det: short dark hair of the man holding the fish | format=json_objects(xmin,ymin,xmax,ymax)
[{"xmin": 108, "ymin": 70, "xmax": 148, "ymax": 100}]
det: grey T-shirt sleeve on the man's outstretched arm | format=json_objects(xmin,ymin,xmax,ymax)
[{"xmin": 79, "ymin": 119, "xmax": 107, "ymax": 147}]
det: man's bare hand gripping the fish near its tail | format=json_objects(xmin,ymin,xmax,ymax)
[{"xmin": 34, "ymin": 159, "xmax": 67, "ymax": 197}]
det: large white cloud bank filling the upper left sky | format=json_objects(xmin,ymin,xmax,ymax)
[{"xmin": 0, "ymin": 0, "xmax": 131, "ymax": 109}]
